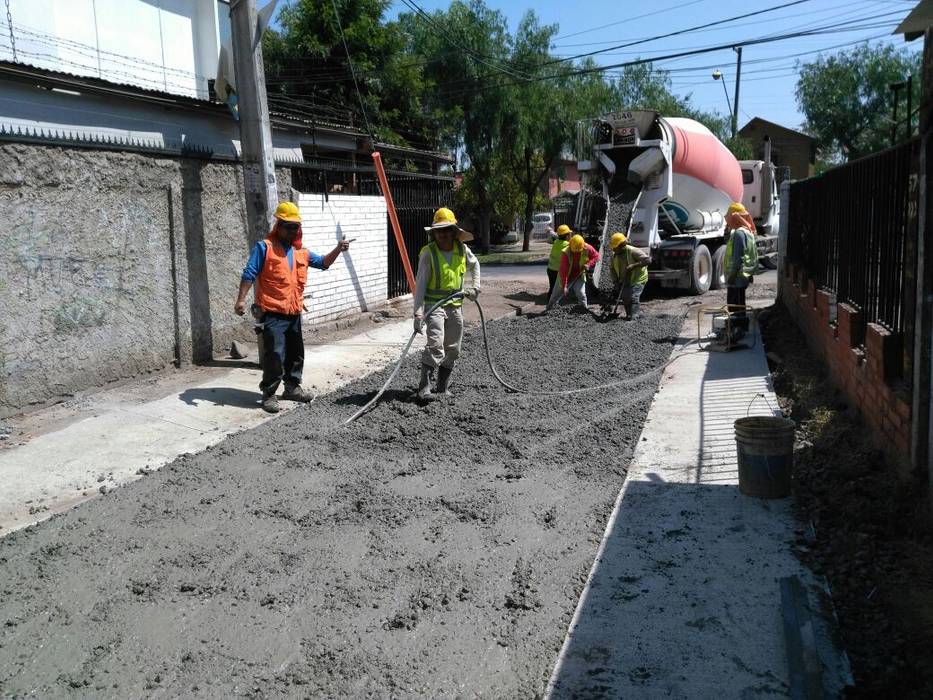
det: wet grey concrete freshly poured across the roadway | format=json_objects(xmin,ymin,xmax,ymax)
[{"xmin": 0, "ymin": 311, "xmax": 680, "ymax": 698}]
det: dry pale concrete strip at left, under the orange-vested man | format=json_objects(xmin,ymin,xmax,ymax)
[{"xmin": 0, "ymin": 321, "xmax": 416, "ymax": 536}]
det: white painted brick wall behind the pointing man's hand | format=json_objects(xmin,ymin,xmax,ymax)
[{"xmin": 298, "ymin": 194, "xmax": 388, "ymax": 323}]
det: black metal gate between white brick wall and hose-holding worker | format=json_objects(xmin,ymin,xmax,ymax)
[{"xmin": 361, "ymin": 174, "xmax": 454, "ymax": 299}]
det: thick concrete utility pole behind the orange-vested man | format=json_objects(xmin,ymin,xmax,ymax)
[{"xmin": 230, "ymin": 0, "xmax": 278, "ymax": 241}]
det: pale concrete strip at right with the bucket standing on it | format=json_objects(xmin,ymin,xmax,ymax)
[{"xmin": 549, "ymin": 315, "xmax": 848, "ymax": 698}]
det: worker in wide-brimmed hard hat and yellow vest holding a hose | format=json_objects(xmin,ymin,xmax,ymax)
[{"xmin": 414, "ymin": 207, "xmax": 480, "ymax": 401}]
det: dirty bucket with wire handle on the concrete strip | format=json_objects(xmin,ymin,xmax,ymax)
[{"xmin": 735, "ymin": 416, "xmax": 796, "ymax": 498}]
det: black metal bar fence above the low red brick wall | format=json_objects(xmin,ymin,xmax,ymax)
[{"xmin": 787, "ymin": 139, "xmax": 919, "ymax": 343}]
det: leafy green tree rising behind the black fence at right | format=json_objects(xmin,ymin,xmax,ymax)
[{"xmin": 797, "ymin": 43, "xmax": 920, "ymax": 161}]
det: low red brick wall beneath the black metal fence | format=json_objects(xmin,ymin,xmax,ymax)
[{"xmin": 781, "ymin": 263, "xmax": 911, "ymax": 468}]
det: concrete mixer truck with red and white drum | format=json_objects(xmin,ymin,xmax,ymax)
[{"xmin": 574, "ymin": 111, "xmax": 780, "ymax": 294}]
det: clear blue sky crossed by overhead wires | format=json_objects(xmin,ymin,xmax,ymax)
[{"xmin": 374, "ymin": 0, "xmax": 923, "ymax": 133}]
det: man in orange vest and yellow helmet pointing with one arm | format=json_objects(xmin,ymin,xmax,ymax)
[{"xmin": 233, "ymin": 202, "xmax": 350, "ymax": 413}]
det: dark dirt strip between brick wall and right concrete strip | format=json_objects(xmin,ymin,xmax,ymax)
[{"xmin": 762, "ymin": 306, "xmax": 933, "ymax": 698}]
